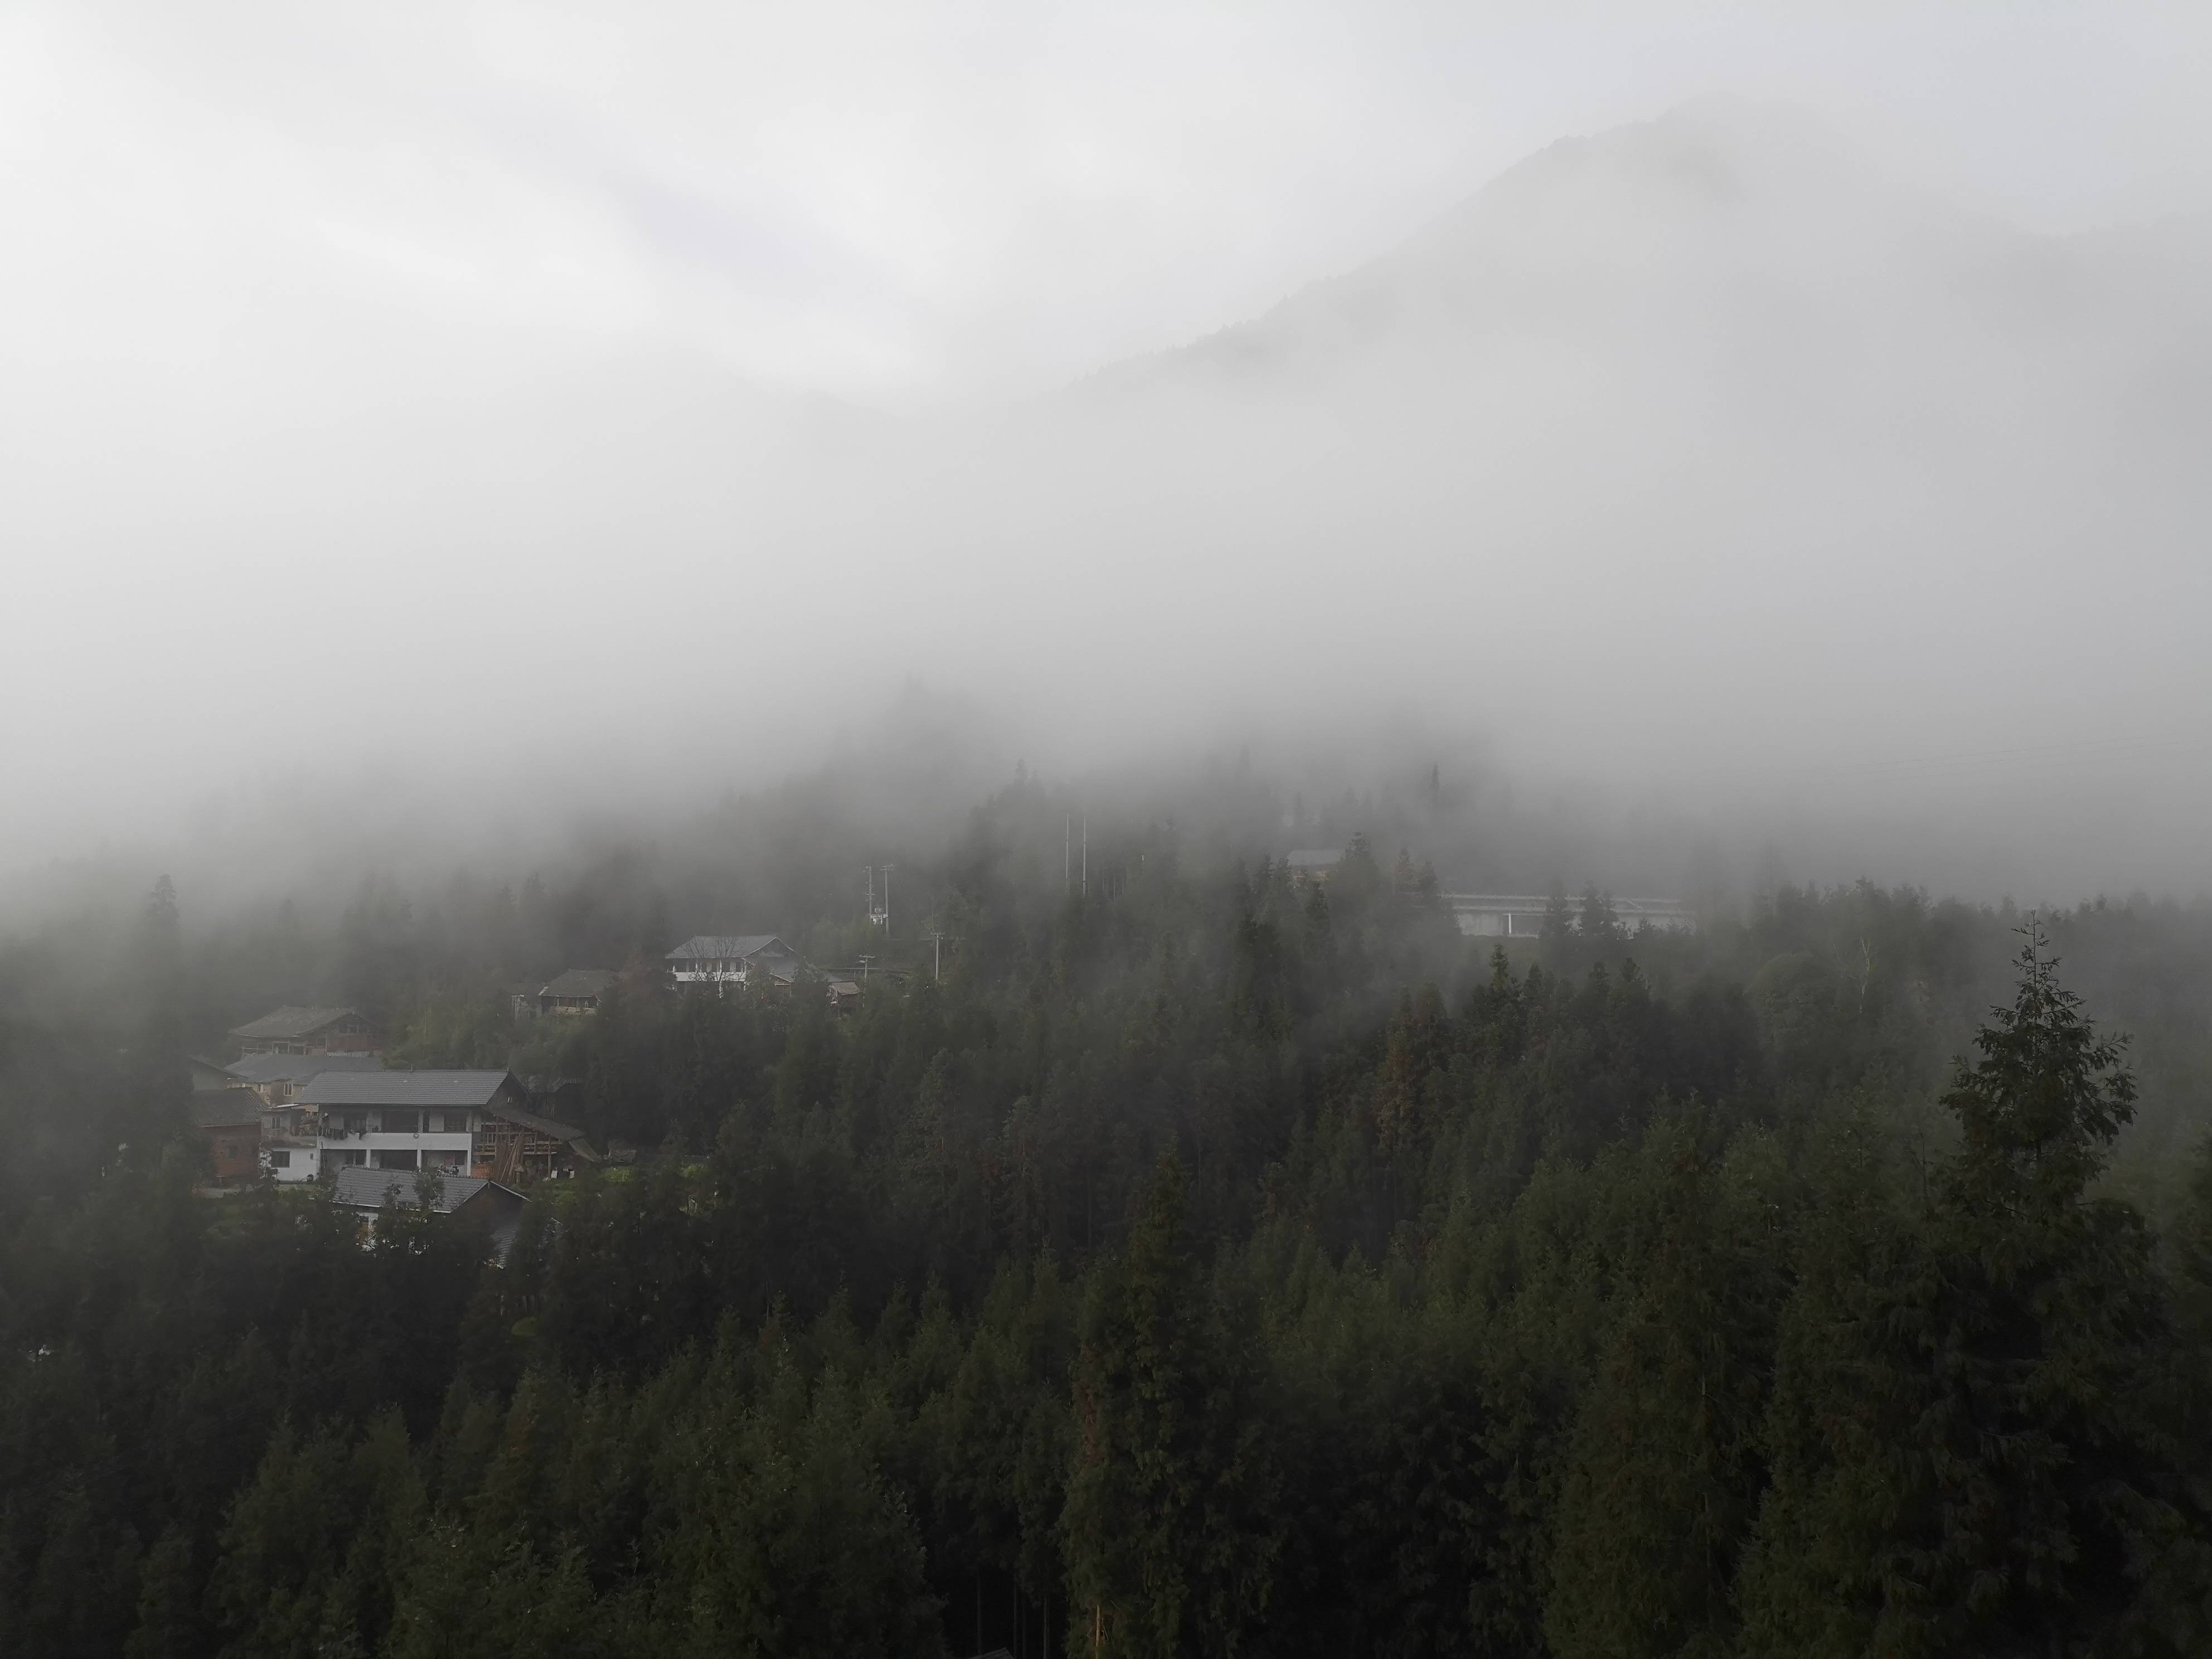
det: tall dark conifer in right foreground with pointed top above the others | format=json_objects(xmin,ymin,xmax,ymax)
[{"xmin": 1743, "ymin": 923, "xmax": 2212, "ymax": 1655}]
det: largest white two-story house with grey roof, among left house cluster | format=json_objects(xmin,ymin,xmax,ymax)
[{"xmin": 278, "ymin": 1071, "xmax": 528, "ymax": 1181}]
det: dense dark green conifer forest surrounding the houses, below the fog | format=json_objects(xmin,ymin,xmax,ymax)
[{"xmin": 0, "ymin": 783, "xmax": 2212, "ymax": 1659}]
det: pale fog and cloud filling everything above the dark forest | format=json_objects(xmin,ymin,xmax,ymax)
[{"xmin": 0, "ymin": 7, "xmax": 2212, "ymax": 898}]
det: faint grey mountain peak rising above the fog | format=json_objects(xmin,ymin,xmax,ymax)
[{"xmin": 1104, "ymin": 100, "xmax": 2148, "ymax": 407}]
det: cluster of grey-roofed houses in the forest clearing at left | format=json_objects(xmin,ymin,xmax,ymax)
[{"xmin": 192, "ymin": 1008, "xmax": 599, "ymax": 1201}]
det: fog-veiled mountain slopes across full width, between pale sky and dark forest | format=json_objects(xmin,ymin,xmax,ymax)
[{"xmin": 0, "ymin": 102, "xmax": 2212, "ymax": 894}]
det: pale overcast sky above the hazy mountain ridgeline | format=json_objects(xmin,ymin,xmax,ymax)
[{"xmin": 0, "ymin": 0, "xmax": 2212, "ymax": 400}]
